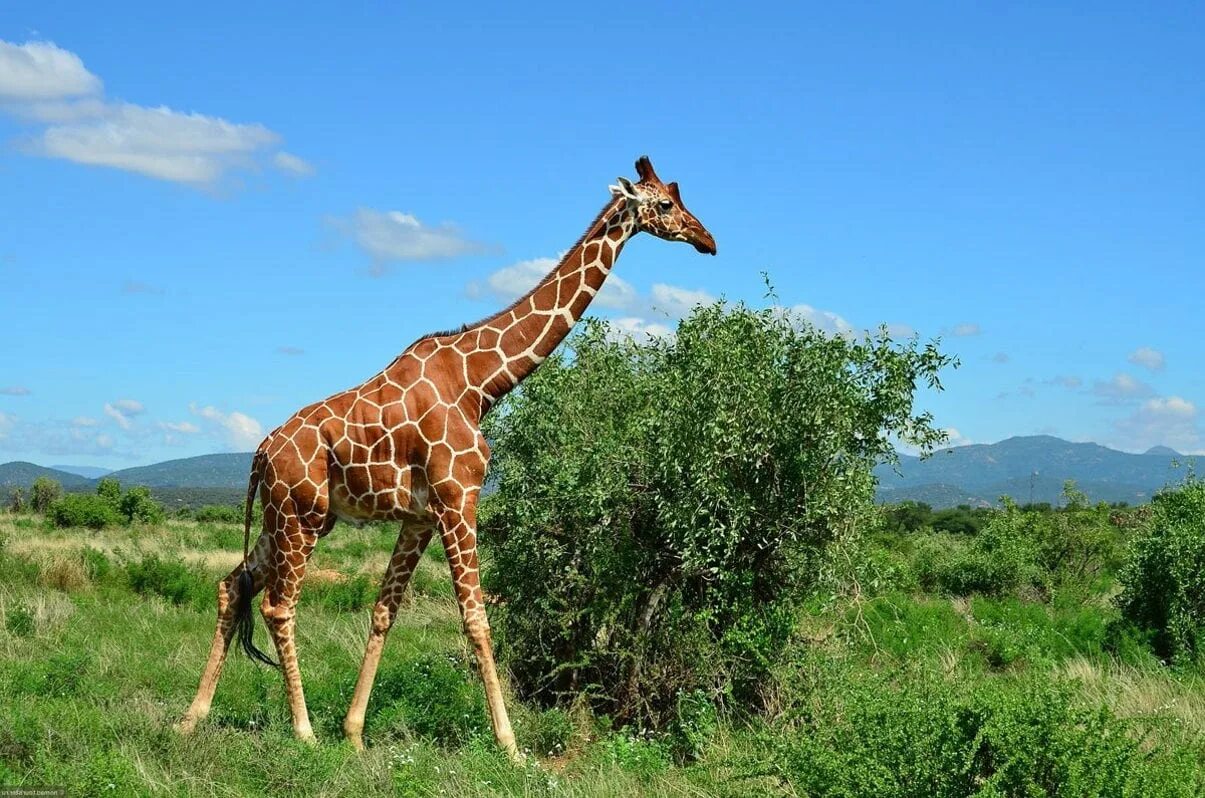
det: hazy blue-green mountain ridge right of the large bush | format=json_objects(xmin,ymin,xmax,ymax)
[{"xmin": 875, "ymin": 435, "xmax": 1188, "ymax": 507}]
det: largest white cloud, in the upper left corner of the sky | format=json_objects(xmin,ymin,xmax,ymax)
[{"xmin": 0, "ymin": 41, "xmax": 312, "ymax": 187}]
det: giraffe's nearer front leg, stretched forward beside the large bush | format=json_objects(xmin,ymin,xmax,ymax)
[{"xmin": 439, "ymin": 489, "xmax": 523, "ymax": 762}]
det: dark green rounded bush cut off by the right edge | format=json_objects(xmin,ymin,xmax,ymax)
[{"xmin": 1117, "ymin": 480, "xmax": 1205, "ymax": 661}]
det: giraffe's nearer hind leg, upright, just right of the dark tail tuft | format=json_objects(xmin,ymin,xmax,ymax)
[{"xmin": 260, "ymin": 498, "xmax": 325, "ymax": 743}]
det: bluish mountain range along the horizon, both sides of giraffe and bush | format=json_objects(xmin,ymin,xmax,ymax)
[{"xmin": 0, "ymin": 435, "xmax": 1192, "ymax": 507}]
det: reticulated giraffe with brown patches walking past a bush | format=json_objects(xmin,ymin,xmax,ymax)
[{"xmin": 178, "ymin": 157, "xmax": 716, "ymax": 758}]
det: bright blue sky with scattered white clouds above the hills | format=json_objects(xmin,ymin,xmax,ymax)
[{"xmin": 0, "ymin": 0, "xmax": 1205, "ymax": 468}]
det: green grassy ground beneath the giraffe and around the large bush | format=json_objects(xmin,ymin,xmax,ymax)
[{"xmin": 0, "ymin": 516, "xmax": 1205, "ymax": 798}]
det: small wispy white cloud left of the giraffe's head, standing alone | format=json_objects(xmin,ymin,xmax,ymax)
[{"xmin": 327, "ymin": 207, "xmax": 489, "ymax": 275}]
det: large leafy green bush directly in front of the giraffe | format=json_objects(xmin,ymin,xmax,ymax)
[{"xmin": 480, "ymin": 305, "xmax": 951, "ymax": 728}]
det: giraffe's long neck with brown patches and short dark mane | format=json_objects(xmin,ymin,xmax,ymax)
[{"xmin": 468, "ymin": 198, "xmax": 636, "ymax": 405}]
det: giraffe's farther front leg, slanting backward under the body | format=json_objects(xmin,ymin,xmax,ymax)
[{"xmin": 343, "ymin": 523, "xmax": 434, "ymax": 750}]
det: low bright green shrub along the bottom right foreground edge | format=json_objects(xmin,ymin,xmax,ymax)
[{"xmin": 759, "ymin": 675, "xmax": 1203, "ymax": 798}]
